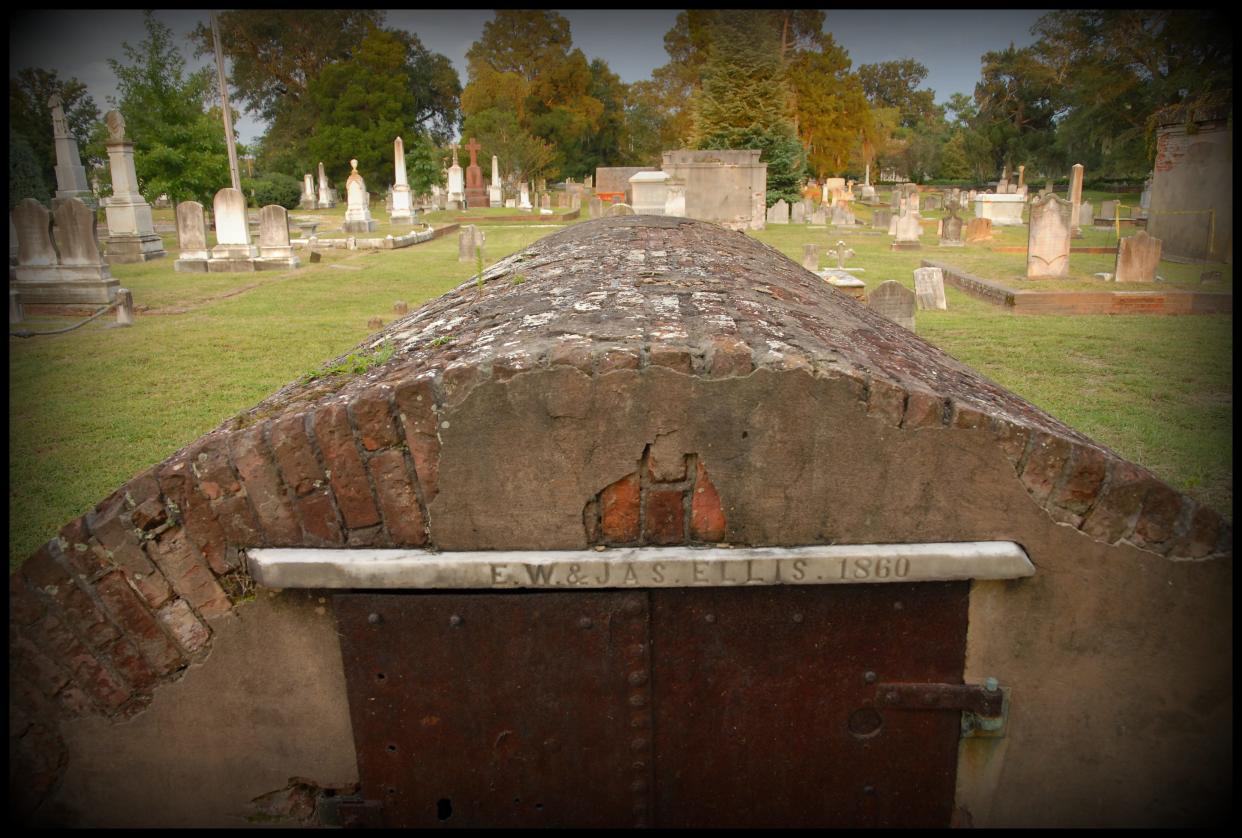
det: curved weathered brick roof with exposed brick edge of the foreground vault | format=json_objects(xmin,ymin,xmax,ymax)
[{"xmin": 10, "ymin": 216, "xmax": 1232, "ymax": 734}]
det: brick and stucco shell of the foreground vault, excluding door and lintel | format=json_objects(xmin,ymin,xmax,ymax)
[{"xmin": 10, "ymin": 216, "xmax": 1232, "ymax": 826}]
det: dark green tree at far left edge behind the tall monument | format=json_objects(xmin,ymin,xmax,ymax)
[{"xmin": 9, "ymin": 67, "xmax": 103, "ymax": 184}]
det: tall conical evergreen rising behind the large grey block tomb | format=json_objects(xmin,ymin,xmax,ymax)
[{"xmin": 692, "ymin": 11, "xmax": 806, "ymax": 206}]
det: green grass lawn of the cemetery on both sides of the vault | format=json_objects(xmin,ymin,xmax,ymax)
[{"xmin": 9, "ymin": 192, "xmax": 1233, "ymax": 569}]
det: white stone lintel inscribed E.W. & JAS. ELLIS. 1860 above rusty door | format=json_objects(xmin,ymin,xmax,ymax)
[{"xmin": 247, "ymin": 541, "xmax": 1035, "ymax": 590}]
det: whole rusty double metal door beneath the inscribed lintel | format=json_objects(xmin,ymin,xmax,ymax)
[{"xmin": 335, "ymin": 582, "xmax": 969, "ymax": 827}]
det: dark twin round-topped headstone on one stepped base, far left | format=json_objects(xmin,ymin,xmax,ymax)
[{"xmin": 10, "ymin": 197, "xmax": 120, "ymax": 305}]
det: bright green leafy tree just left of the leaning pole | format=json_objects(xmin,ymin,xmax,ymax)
[{"xmin": 106, "ymin": 11, "xmax": 229, "ymax": 204}]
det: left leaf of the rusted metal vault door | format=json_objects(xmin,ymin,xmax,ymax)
[{"xmin": 334, "ymin": 591, "xmax": 652, "ymax": 827}]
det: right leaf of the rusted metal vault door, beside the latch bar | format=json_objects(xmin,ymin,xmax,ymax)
[{"xmin": 652, "ymin": 582, "xmax": 969, "ymax": 827}]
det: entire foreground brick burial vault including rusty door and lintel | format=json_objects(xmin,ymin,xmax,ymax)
[{"xmin": 9, "ymin": 216, "xmax": 1232, "ymax": 827}]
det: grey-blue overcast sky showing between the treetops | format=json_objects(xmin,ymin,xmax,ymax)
[{"xmin": 9, "ymin": 9, "xmax": 1043, "ymax": 143}]
